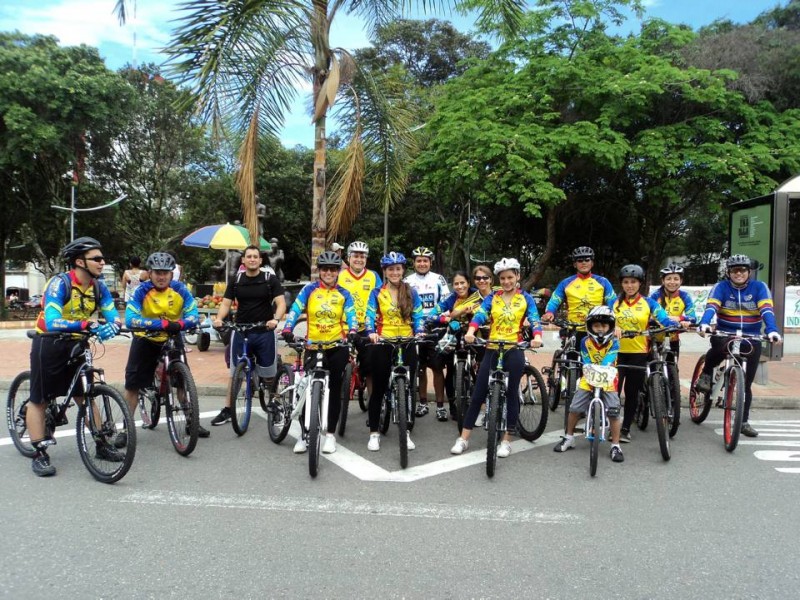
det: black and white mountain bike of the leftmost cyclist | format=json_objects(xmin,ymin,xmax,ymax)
[{"xmin": 6, "ymin": 331, "xmax": 136, "ymax": 483}]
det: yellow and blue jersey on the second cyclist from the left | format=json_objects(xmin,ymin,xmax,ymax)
[{"xmin": 125, "ymin": 280, "xmax": 199, "ymax": 342}]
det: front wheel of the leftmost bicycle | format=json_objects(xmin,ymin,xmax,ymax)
[{"xmin": 76, "ymin": 383, "xmax": 136, "ymax": 483}]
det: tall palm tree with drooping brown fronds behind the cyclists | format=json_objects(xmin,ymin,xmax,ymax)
[{"xmin": 115, "ymin": 0, "xmax": 527, "ymax": 274}]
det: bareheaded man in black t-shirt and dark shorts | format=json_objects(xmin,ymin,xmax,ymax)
[{"xmin": 211, "ymin": 246, "xmax": 286, "ymax": 425}]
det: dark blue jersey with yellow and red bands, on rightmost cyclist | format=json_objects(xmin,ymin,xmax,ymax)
[{"xmin": 700, "ymin": 279, "xmax": 778, "ymax": 335}]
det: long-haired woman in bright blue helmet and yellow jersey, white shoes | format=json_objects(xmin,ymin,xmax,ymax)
[{"xmin": 366, "ymin": 252, "xmax": 424, "ymax": 452}]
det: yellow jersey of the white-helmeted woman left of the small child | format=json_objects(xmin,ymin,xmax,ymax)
[{"xmin": 469, "ymin": 289, "xmax": 542, "ymax": 342}]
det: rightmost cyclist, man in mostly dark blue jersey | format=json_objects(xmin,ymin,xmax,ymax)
[{"xmin": 695, "ymin": 254, "xmax": 782, "ymax": 437}]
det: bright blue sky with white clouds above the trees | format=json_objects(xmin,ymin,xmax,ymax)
[{"xmin": 0, "ymin": 0, "xmax": 786, "ymax": 148}]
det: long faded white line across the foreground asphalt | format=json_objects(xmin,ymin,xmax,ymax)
[{"xmin": 115, "ymin": 490, "xmax": 582, "ymax": 524}]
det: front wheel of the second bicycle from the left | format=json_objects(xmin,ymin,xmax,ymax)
[{"xmin": 167, "ymin": 361, "xmax": 200, "ymax": 456}]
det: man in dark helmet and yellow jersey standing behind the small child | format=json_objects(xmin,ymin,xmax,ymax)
[{"xmin": 542, "ymin": 246, "xmax": 617, "ymax": 344}]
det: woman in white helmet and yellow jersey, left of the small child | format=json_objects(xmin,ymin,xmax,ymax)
[{"xmin": 450, "ymin": 258, "xmax": 542, "ymax": 458}]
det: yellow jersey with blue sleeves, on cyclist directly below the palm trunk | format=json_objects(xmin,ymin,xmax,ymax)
[{"xmin": 284, "ymin": 281, "xmax": 358, "ymax": 342}]
